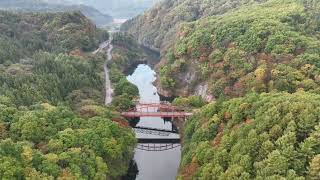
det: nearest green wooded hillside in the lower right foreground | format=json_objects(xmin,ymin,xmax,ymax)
[{"xmin": 178, "ymin": 92, "xmax": 320, "ymax": 180}]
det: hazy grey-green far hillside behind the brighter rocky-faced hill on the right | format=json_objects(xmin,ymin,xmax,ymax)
[{"xmin": 121, "ymin": 0, "xmax": 265, "ymax": 50}]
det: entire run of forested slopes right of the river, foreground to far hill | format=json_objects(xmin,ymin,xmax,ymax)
[{"xmin": 122, "ymin": 0, "xmax": 320, "ymax": 180}]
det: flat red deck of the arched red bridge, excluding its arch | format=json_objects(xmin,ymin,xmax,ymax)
[{"xmin": 121, "ymin": 112, "xmax": 192, "ymax": 118}]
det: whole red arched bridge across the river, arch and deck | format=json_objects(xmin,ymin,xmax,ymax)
[{"xmin": 121, "ymin": 102, "xmax": 192, "ymax": 118}]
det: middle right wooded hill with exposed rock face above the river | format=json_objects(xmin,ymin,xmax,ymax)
[{"xmin": 154, "ymin": 0, "xmax": 320, "ymax": 99}]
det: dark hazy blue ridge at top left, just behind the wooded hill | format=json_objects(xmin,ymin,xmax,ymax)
[{"xmin": 0, "ymin": 0, "xmax": 113, "ymax": 26}]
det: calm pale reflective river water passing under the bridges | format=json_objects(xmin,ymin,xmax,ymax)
[{"xmin": 127, "ymin": 65, "xmax": 181, "ymax": 180}]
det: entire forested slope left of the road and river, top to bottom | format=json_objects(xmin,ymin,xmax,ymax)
[{"xmin": 0, "ymin": 11, "xmax": 136, "ymax": 179}]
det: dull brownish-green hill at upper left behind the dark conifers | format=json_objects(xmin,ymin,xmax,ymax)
[{"xmin": 0, "ymin": 11, "xmax": 108, "ymax": 63}]
